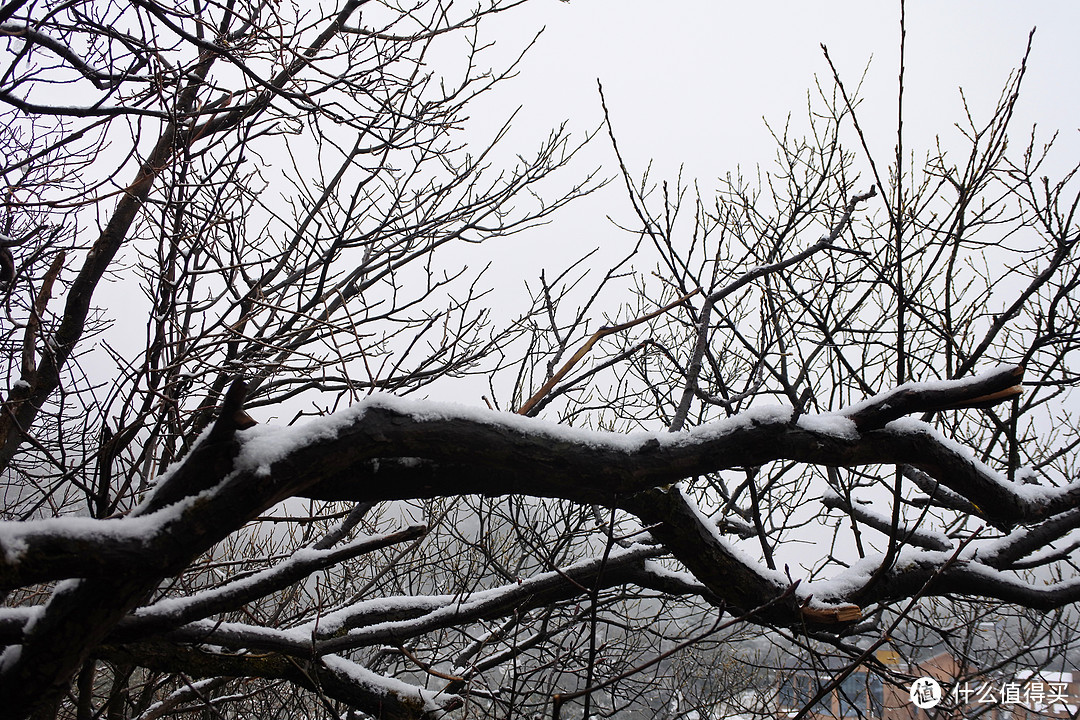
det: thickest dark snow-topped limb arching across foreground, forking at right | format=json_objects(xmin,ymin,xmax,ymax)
[{"xmin": 0, "ymin": 368, "xmax": 1080, "ymax": 708}]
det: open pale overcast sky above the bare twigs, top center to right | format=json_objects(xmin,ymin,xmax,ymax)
[{"xmin": 473, "ymin": 0, "xmax": 1080, "ymax": 287}]
